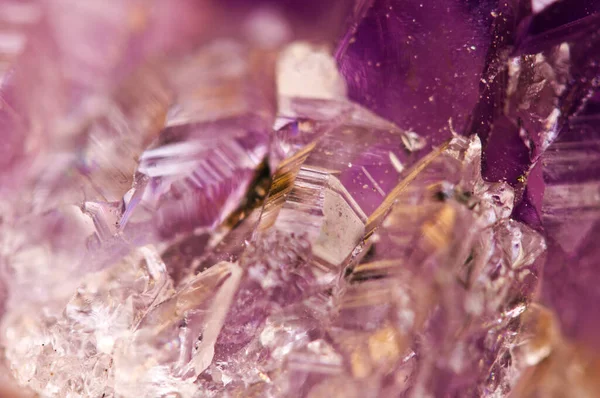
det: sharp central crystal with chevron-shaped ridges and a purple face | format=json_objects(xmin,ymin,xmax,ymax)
[{"xmin": 259, "ymin": 43, "xmax": 421, "ymax": 284}]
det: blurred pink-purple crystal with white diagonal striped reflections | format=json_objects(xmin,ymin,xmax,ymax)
[{"xmin": 120, "ymin": 42, "xmax": 272, "ymax": 236}]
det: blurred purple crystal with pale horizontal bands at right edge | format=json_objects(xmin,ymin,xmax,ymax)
[{"xmin": 542, "ymin": 91, "xmax": 600, "ymax": 349}]
